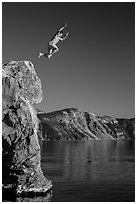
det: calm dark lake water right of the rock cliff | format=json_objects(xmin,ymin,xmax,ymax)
[{"xmin": 41, "ymin": 140, "xmax": 135, "ymax": 202}]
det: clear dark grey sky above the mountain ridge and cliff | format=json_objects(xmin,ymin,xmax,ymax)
[{"xmin": 2, "ymin": 2, "xmax": 135, "ymax": 118}]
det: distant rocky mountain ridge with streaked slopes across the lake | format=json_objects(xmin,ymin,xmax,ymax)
[{"xmin": 37, "ymin": 108, "xmax": 135, "ymax": 140}]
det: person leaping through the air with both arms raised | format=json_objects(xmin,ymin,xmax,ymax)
[{"xmin": 38, "ymin": 23, "xmax": 68, "ymax": 59}]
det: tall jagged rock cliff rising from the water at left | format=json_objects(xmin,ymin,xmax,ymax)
[{"xmin": 2, "ymin": 61, "xmax": 52, "ymax": 198}]
